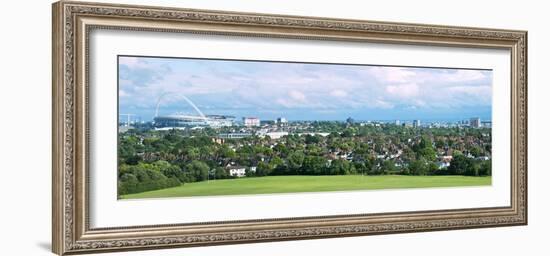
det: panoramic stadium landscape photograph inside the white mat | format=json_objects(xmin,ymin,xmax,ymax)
[{"xmin": 117, "ymin": 56, "xmax": 493, "ymax": 200}]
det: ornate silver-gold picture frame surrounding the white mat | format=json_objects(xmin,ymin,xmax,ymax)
[{"xmin": 52, "ymin": 1, "xmax": 527, "ymax": 255}]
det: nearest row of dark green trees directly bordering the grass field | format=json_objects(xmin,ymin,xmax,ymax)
[{"xmin": 118, "ymin": 153, "xmax": 491, "ymax": 195}]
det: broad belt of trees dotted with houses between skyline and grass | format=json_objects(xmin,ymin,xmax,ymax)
[{"xmin": 118, "ymin": 122, "xmax": 491, "ymax": 194}]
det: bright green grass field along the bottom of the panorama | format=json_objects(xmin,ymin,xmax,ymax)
[{"xmin": 121, "ymin": 175, "xmax": 491, "ymax": 199}]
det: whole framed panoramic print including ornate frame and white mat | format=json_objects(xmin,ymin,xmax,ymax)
[{"xmin": 52, "ymin": 1, "xmax": 527, "ymax": 255}]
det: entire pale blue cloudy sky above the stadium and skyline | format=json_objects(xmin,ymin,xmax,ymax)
[{"xmin": 119, "ymin": 56, "xmax": 492, "ymax": 121}]
